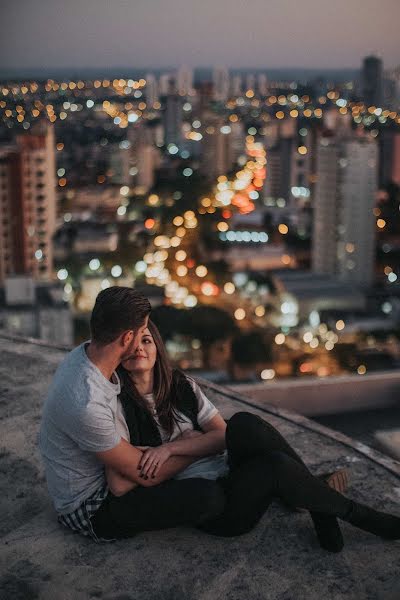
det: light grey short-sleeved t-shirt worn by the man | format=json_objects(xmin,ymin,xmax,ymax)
[{"xmin": 39, "ymin": 342, "xmax": 121, "ymax": 514}]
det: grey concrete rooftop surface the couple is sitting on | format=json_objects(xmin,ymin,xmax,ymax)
[{"xmin": 0, "ymin": 336, "xmax": 400, "ymax": 600}]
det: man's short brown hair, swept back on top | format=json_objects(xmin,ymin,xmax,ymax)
[{"xmin": 90, "ymin": 286, "xmax": 151, "ymax": 344}]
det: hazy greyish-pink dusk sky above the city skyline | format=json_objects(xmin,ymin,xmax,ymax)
[{"xmin": 0, "ymin": 0, "xmax": 400, "ymax": 72}]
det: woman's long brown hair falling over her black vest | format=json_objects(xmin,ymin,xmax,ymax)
[{"xmin": 122, "ymin": 319, "xmax": 185, "ymax": 435}]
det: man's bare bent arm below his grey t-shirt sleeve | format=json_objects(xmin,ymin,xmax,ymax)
[{"xmin": 96, "ymin": 439, "xmax": 196, "ymax": 496}]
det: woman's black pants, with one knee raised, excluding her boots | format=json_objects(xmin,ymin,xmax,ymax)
[{"xmin": 200, "ymin": 412, "xmax": 351, "ymax": 536}]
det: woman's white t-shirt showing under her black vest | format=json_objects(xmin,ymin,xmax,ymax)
[{"xmin": 115, "ymin": 377, "xmax": 229, "ymax": 480}]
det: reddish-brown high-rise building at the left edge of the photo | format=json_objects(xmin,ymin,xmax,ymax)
[{"xmin": 0, "ymin": 125, "xmax": 56, "ymax": 282}]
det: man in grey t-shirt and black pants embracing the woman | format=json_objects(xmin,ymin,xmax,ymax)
[{"xmin": 39, "ymin": 287, "xmax": 224, "ymax": 541}]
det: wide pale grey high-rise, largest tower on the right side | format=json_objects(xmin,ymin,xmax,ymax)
[{"xmin": 312, "ymin": 134, "xmax": 378, "ymax": 286}]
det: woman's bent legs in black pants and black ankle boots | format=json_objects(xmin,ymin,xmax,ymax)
[{"xmin": 202, "ymin": 413, "xmax": 400, "ymax": 552}]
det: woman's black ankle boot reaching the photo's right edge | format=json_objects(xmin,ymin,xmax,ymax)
[{"xmin": 343, "ymin": 500, "xmax": 400, "ymax": 540}]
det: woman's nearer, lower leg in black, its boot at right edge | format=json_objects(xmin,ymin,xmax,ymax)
[{"xmin": 200, "ymin": 451, "xmax": 400, "ymax": 551}]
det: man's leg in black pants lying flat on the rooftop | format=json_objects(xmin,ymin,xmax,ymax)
[{"xmin": 91, "ymin": 478, "xmax": 225, "ymax": 538}]
